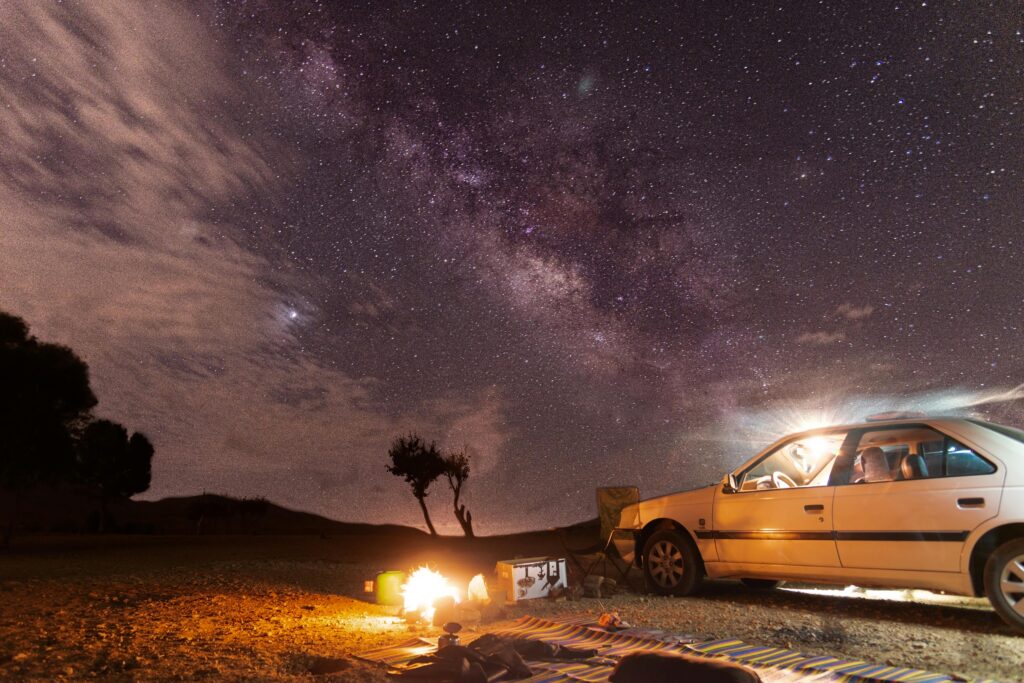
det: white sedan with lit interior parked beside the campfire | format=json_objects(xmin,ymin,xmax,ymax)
[{"xmin": 616, "ymin": 417, "xmax": 1024, "ymax": 632}]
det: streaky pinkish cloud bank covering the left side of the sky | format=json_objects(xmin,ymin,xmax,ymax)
[{"xmin": 0, "ymin": 2, "xmax": 512, "ymax": 523}]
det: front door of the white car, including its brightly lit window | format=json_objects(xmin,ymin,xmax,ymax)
[{"xmin": 711, "ymin": 432, "xmax": 845, "ymax": 569}]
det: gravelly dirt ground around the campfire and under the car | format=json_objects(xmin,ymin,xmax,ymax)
[{"xmin": 0, "ymin": 533, "xmax": 1024, "ymax": 681}]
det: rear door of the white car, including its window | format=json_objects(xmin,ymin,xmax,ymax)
[{"xmin": 834, "ymin": 425, "xmax": 1004, "ymax": 571}]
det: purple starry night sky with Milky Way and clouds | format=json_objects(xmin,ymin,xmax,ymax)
[{"xmin": 0, "ymin": 0, "xmax": 1024, "ymax": 533}]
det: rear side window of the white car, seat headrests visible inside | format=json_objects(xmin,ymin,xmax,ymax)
[{"xmin": 850, "ymin": 425, "xmax": 995, "ymax": 483}]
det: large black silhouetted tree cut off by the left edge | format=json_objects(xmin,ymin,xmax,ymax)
[{"xmin": 0, "ymin": 312, "xmax": 96, "ymax": 548}]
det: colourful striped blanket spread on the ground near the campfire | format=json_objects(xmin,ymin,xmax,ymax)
[{"xmin": 357, "ymin": 616, "xmax": 994, "ymax": 683}]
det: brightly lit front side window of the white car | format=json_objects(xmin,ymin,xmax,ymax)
[{"xmin": 739, "ymin": 431, "xmax": 847, "ymax": 492}]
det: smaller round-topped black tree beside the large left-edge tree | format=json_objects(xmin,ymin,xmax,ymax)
[{"xmin": 78, "ymin": 420, "xmax": 153, "ymax": 533}]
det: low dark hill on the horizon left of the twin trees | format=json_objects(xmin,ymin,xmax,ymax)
[{"xmin": 4, "ymin": 488, "xmax": 426, "ymax": 537}]
